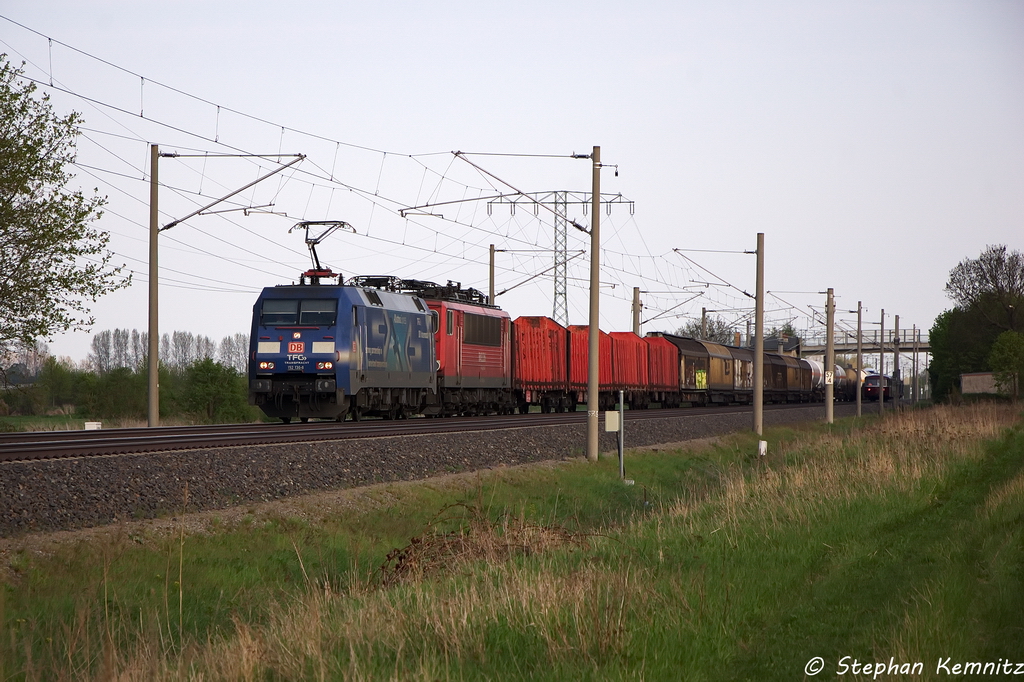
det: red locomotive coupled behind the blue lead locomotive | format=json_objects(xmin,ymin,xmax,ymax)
[{"xmin": 427, "ymin": 300, "xmax": 512, "ymax": 414}]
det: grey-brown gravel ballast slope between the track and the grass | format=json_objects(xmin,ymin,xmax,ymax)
[{"xmin": 0, "ymin": 404, "xmax": 854, "ymax": 538}]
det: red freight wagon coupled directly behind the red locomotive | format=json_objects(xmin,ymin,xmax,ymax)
[{"xmin": 512, "ymin": 316, "xmax": 575, "ymax": 413}]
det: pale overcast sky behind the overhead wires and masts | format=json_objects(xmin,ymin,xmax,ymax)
[{"xmin": 0, "ymin": 0, "xmax": 1024, "ymax": 359}]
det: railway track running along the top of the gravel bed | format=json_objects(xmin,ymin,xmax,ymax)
[{"xmin": 0, "ymin": 404, "xmax": 807, "ymax": 462}]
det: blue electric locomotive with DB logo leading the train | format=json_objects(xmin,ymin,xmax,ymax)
[{"xmin": 249, "ymin": 223, "xmax": 437, "ymax": 423}]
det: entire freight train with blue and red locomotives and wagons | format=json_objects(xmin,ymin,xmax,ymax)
[{"xmin": 249, "ymin": 270, "xmax": 855, "ymax": 423}]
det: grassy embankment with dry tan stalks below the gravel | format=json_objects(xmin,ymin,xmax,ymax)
[{"xmin": 0, "ymin": 406, "xmax": 1024, "ymax": 680}]
